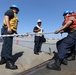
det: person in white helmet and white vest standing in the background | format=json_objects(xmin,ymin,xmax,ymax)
[{"xmin": 33, "ymin": 19, "xmax": 43, "ymax": 55}]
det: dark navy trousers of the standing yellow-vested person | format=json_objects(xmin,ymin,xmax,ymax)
[{"xmin": 1, "ymin": 27, "xmax": 14, "ymax": 60}]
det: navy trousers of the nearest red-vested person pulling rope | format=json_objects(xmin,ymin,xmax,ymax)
[{"xmin": 56, "ymin": 31, "xmax": 76, "ymax": 59}]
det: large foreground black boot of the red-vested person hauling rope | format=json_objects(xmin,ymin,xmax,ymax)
[{"xmin": 47, "ymin": 58, "xmax": 61, "ymax": 71}]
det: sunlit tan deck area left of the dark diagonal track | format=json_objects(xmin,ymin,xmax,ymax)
[{"xmin": 0, "ymin": 43, "xmax": 53, "ymax": 75}]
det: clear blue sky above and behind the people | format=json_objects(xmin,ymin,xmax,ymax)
[{"xmin": 0, "ymin": 0, "xmax": 76, "ymax": 38}]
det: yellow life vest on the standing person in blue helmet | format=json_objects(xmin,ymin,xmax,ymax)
[{"xmin": 4, "ymin": 13, "xmax": 18, "ymax": 31}]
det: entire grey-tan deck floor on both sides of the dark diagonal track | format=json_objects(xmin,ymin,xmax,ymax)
[{"xmin": 0, "ymin": 39, "xmax": 76, "ymax": 75}]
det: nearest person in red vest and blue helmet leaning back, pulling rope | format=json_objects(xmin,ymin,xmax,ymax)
[{"xmin": 47, "ymin": 11, "xmax": 76, "ymax": 71}]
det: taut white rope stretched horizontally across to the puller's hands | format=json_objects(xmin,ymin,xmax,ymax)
[{"xmin": 0, "ymin": 32, "xmax": 54, "ymax": 37}]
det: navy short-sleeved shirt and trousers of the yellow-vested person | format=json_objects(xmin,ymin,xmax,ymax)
[{"xmin": 1, "ymin": 10, "xmax": 14, "ymax": 60}]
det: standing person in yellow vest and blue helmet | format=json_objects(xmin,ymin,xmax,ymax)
[{"xmin": 0, "ymin": 5, "xmax": 19, "ymax": 70}]
